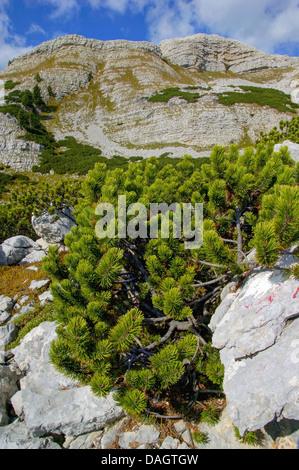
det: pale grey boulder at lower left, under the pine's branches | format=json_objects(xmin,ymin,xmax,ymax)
[{"xmin": 11, "ymin": 322, "xmax": 124, "ymax": 437}]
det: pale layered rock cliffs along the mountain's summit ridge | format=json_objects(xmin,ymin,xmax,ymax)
[{"xmin": 9, "ymin": 34, "xmax": 298, "ymax": 78}]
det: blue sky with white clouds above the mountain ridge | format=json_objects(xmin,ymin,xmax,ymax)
[{"xmin": 0, "ymin": 0, "xmax": 299, "ymax": 70}]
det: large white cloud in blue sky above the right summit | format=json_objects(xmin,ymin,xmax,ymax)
[{"xmin": 142, "ymin": 0, "xmax": 299, "ymax": 53}]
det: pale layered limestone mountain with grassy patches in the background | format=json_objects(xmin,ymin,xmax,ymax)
[{"xmin": 0, "ymin": 34, "xmax": 299, "ymax": 169}]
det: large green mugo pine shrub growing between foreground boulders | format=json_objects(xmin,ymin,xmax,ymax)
[{"xmin": 44, "ymin": 144, "xmax": 299, "ymax": 415}]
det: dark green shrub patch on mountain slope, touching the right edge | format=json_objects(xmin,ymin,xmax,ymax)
[{"xmin": 218, "ymin": 86, "xmax": 299, "ymax": 113}]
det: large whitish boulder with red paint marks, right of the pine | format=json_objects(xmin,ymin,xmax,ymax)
[{"xmin": 210, "ymin": 260, "xmax": 299, "ymax": 434}]
